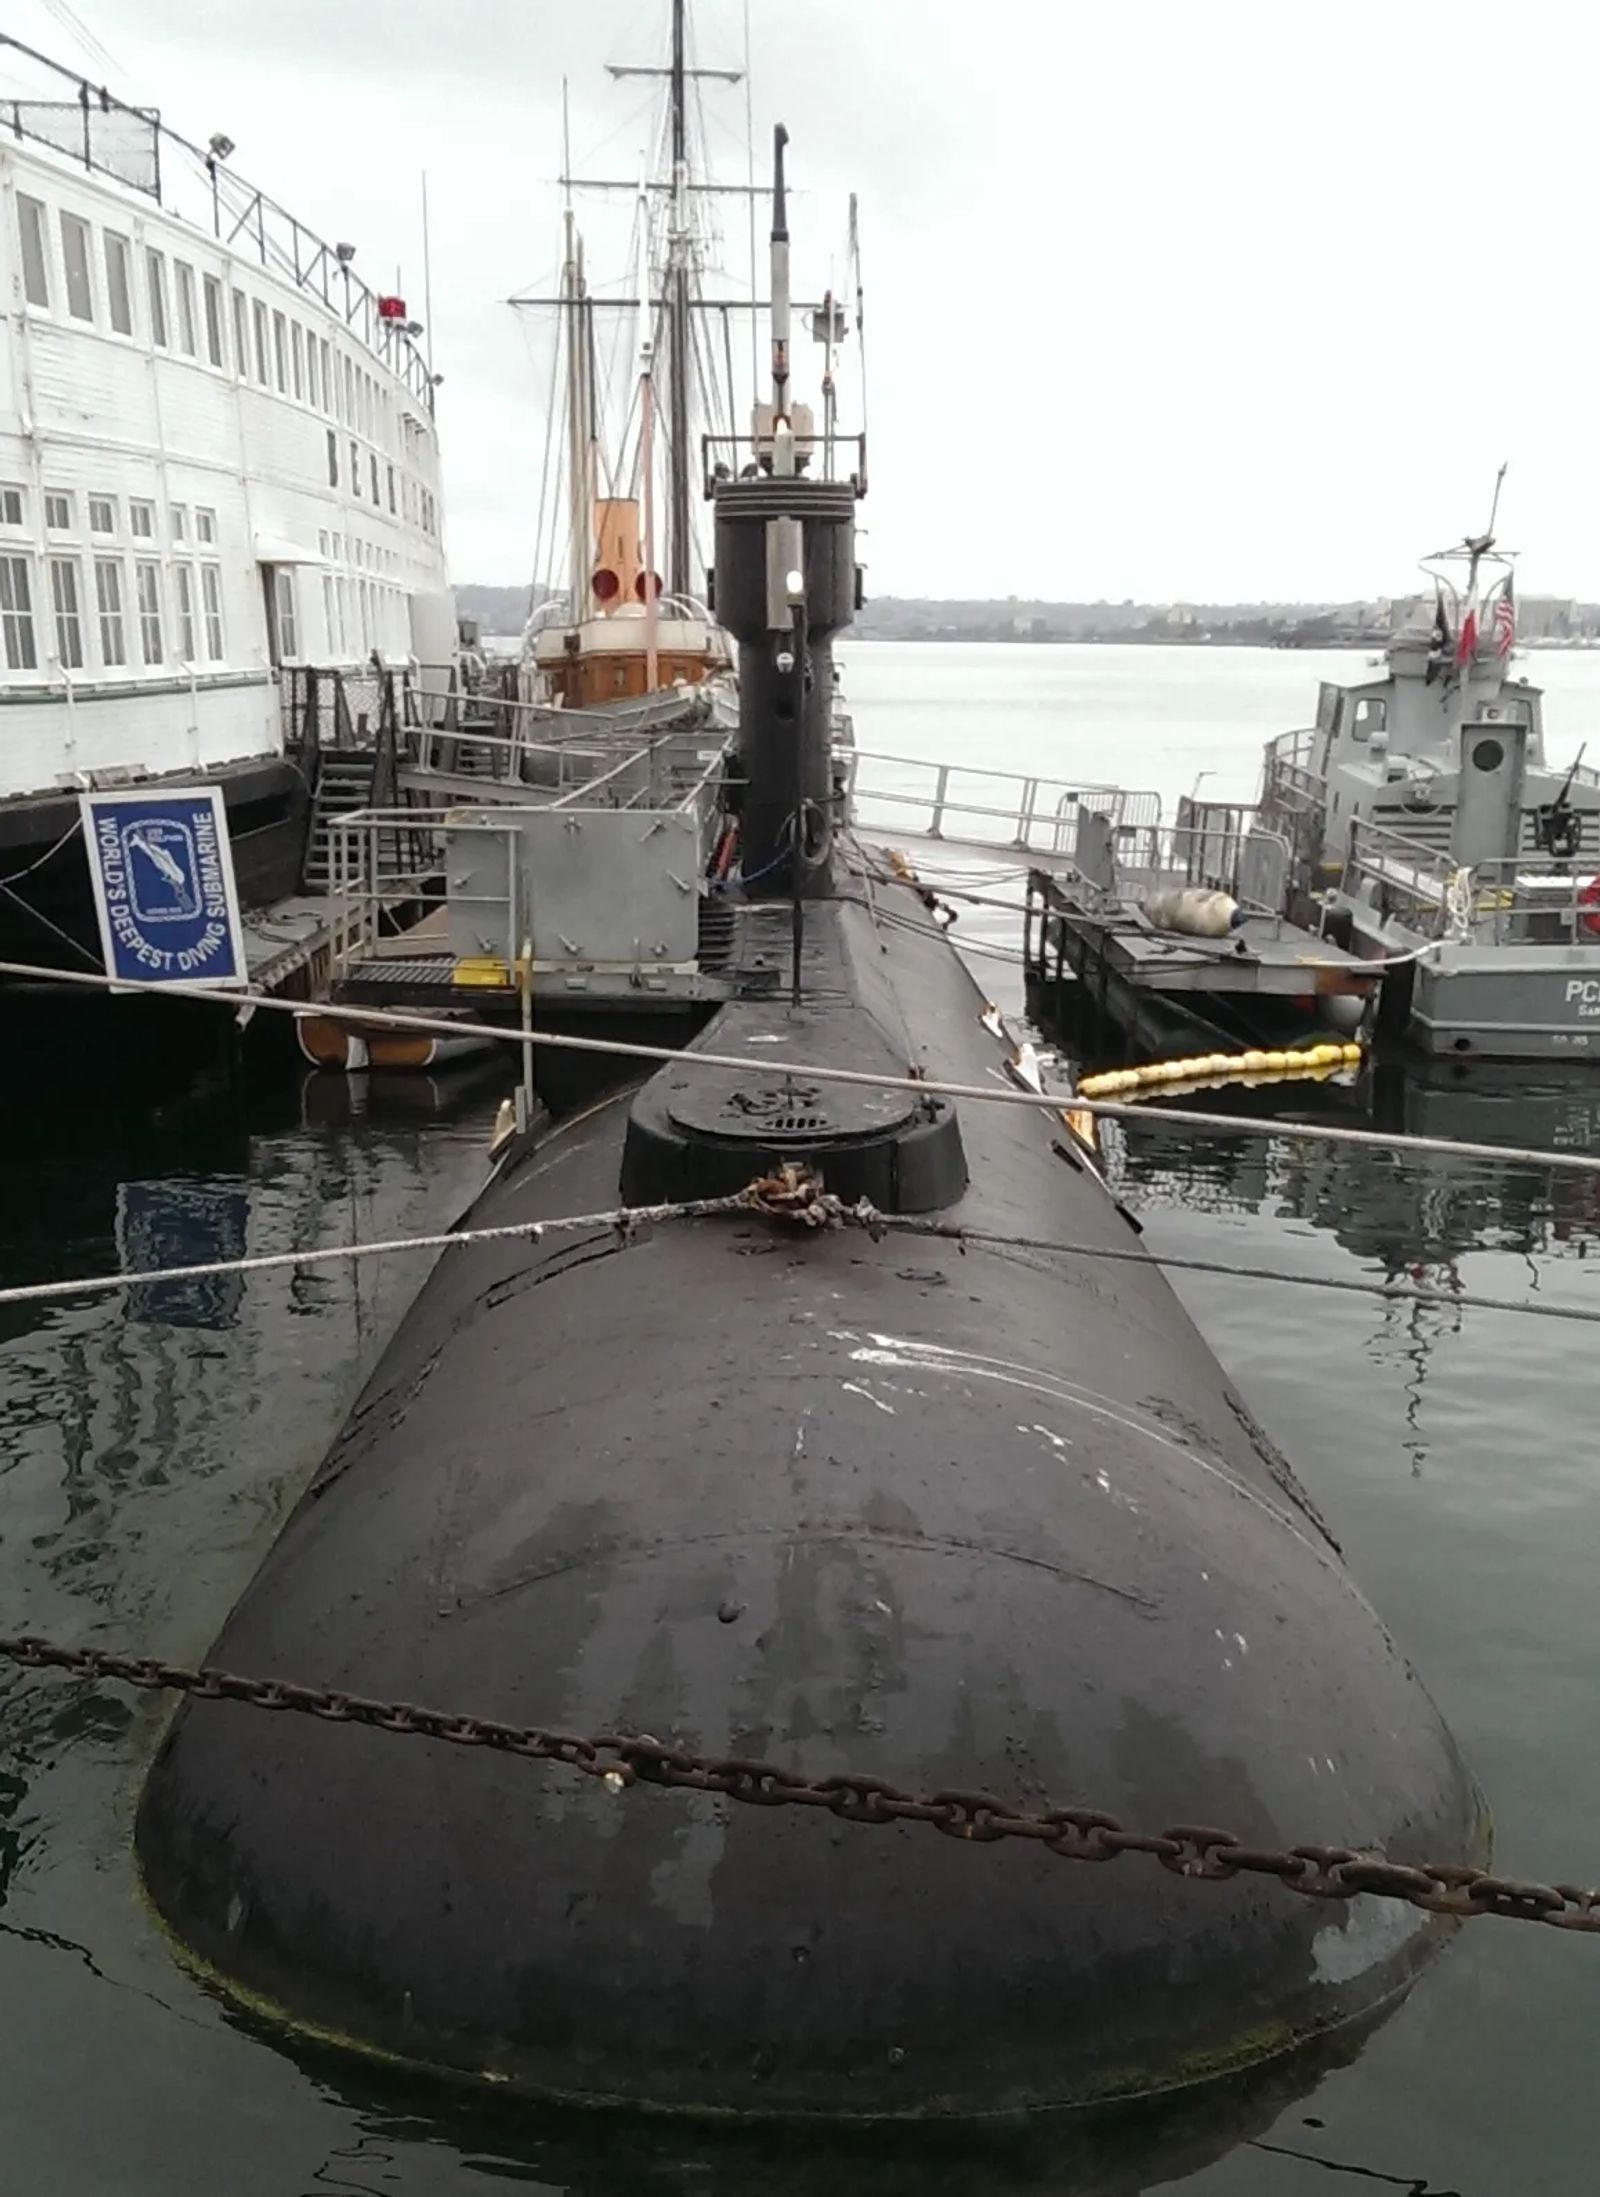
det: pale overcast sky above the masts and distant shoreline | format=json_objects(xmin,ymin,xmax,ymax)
[{"xmin": 18, "ymin": 0, "xmax": 1600, "ymax": 600}]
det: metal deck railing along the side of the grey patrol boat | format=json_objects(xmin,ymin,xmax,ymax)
[{"xmin": 1341, "ymin": 817, "xmax": 1600, "ymax": 947}]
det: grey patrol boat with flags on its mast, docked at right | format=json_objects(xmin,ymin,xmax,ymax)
[{"xmin": 1259, "ymin": 521, "xmax": 1600, "ymax": 1059}]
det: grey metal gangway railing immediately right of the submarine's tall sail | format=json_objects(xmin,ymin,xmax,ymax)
[{"xmin": 837, "ymin": 747, "xmax": 1160, "ymax": 859}]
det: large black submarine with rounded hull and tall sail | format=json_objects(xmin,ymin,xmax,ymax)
[{"xmin": 134, "ymin": 130, "xmax": 1484, "ymax": 2120}]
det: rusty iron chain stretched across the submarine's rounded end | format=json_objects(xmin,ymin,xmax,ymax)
[{"xmin": 0, "ymin": 1635, "xmax": 1600, "ymax": 1933}]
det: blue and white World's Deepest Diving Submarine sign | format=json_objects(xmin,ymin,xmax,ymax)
[{"xmin": 79, "ymin": 787, "xmax": 251, "ymax": 986}]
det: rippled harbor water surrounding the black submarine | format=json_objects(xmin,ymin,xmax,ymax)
[{"xmin": 0, "ymin": 644, "xmax": 1600, "ymax": 2197}]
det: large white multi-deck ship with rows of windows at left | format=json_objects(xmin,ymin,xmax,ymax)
[{"xmin": 0, "ymin": 37, "xmax": 455, "ymax": 962}]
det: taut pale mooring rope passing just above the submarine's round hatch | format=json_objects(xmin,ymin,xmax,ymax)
[{"xmin": 0, "ymin": 962, "xmax": 1600, "ymax": 1175}]
